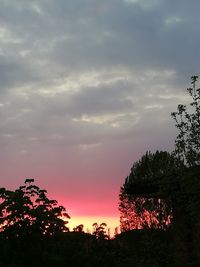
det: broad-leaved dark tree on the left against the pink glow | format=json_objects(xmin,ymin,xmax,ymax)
[{"xmin": 0, "ymin": 179, "xmax": 70, "ymax": 238}]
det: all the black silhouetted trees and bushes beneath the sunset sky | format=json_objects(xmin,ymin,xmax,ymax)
[{"xmin": 0, "ymin": 76, "xmax": 200, "ymax": 267}]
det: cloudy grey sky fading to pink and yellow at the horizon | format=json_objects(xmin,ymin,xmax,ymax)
[{"xmin": 0, "ymin": 0, "xmax": 200, "ymax": 232}]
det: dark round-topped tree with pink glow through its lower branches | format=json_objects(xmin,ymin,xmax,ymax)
[{"xmin": 119, "ymin": 151, "xmax": 178, "ymax": 231}]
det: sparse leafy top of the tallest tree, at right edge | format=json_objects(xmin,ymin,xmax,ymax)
[{"xmin": 171, "ymin": 76, "xmax": 200, "ymax": 166}]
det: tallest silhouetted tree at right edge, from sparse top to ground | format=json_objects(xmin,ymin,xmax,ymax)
[{"xmin": 171, "ymin": 76, "xmax": 200, "ymax": 266}]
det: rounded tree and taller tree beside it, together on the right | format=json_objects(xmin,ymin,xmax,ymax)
[{"xmin": 119, "ymin": 76, "xmax": 200, "ymax": 266}]
